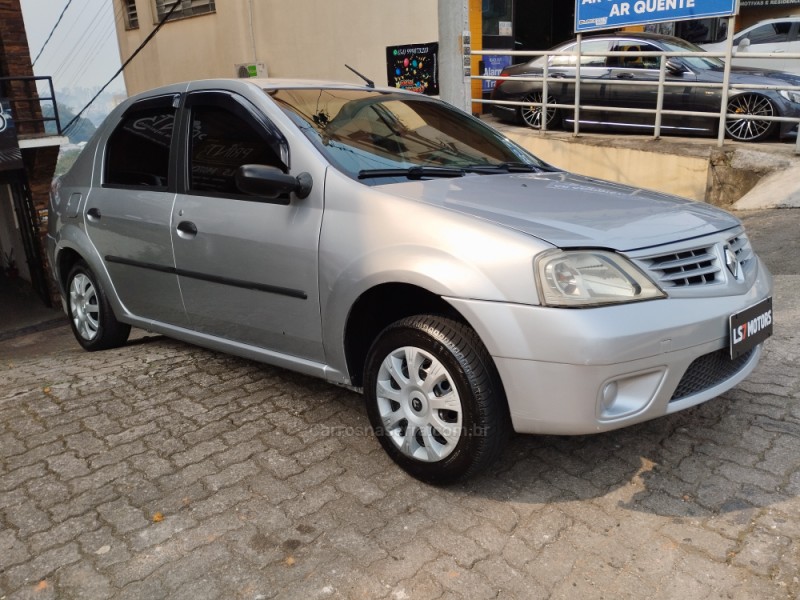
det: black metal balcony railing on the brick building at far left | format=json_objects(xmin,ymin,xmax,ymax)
[{"xmin": 0, "ymin": 76, "xmax": 63, "ymax": 138}]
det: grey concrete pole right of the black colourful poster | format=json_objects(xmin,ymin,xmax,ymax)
[{"xmin": 439, "ymin": 0, "xmax": 472, "ymax": 112}]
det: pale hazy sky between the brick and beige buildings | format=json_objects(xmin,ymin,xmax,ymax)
[{"xmin": 21, "ymin": 0, "xmax": 125, "ymax": 93}]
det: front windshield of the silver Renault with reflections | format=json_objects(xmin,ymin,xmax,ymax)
[{"xmin": 266, "ymin": 88, "xmax": 546, "ymax": 184}]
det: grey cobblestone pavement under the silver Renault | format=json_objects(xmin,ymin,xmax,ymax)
[{"xmin": 0, "ymin": 212, "xmax": 800, "ymax": 600}]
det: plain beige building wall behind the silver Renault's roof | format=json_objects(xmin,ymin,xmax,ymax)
[{"xmin": 113, "ymin": 0, "xmax": 439, "ymax": 95}]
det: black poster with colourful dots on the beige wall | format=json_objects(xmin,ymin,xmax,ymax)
[{"xmin": 386, "ymin": 42, "xmax": 439, "ymax": 96}]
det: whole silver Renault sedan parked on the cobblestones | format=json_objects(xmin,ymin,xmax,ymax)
[{"xmin": 47, "ymin": 79, "xmax": 772, "ymax": 482}]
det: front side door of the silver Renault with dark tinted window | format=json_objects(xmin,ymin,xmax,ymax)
[{"xmin": 172, "ymin": 90, "xmax": 325, "ymax": 360}]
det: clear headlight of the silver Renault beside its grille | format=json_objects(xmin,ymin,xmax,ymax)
[{"xmin": 535, "ymin": 250, "xmax": 666, "ymax": 307}]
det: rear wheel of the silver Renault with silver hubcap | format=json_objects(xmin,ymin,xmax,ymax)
[{"xmin": 66, "ymin": 260, "xmax": 131, "ymax": 352}]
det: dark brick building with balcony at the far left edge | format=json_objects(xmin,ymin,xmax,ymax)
[{"xmin": 0, "ymin": 0, "xmax": 66, "ymax": 306}]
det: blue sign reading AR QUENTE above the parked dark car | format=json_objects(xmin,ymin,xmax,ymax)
[{"xmin": 575, "ymin": 0, "xmax": 737, "ymax": 33}]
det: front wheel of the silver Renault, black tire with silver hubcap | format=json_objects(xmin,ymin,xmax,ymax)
[{"xmin": 364, "ymin": 315, "xmax": 511, "ymax": 484}]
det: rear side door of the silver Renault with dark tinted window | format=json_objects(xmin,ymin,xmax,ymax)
[{"xmin": 85, "ymin": 94, "xmax": 187, "ymax": 326}]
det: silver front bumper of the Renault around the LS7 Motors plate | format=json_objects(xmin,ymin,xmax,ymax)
[{"xmin": 447, "ymin": 264, "xmax": 772, "ymax": 435}]
